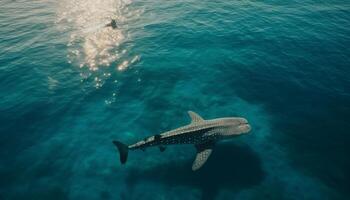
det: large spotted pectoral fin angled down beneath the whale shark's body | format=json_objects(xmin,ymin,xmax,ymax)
[{"xmin": 192, "ymin": 142, "xmax": 214, "ymax": 171}]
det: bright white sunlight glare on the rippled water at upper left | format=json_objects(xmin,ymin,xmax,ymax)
[{"xmin": 57, "ymin": 0, "xmax": 142, "ymax": 92}]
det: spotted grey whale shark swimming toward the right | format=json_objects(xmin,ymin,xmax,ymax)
[{"xmin": 113, "ymin": 111, "xmax": 251, "ymax": 171}]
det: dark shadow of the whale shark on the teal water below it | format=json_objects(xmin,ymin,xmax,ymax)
[{"xmin": 123, "ymin": 143, "xmax": 265, "ymax": 200}]
